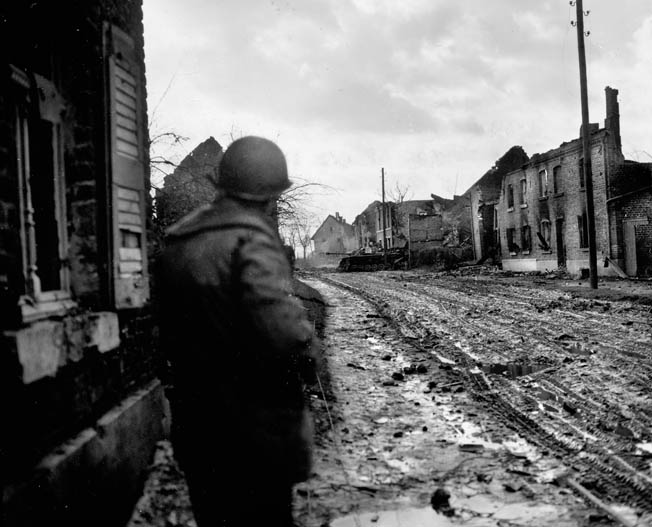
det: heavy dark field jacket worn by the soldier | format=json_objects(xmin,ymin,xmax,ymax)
[{"xmin": 156, "ymin": 198, "xmax": 313, "ymax": 481}]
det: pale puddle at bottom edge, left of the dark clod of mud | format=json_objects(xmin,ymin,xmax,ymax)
[{"xmin": 330, "ymin": 507, "xmax": 453, "ymax": 527}]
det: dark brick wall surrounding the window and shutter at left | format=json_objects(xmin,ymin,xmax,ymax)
[{"xmin": 0, "ymin": 0, "xmax": 158, "ymax": 523}]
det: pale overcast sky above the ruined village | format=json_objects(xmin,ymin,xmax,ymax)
[{"xmin": 144, "ymin": 0, "xmax": 652, "ymax": 225}]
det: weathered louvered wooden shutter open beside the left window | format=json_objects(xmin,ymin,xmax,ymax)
[{"xmin": 106, "ymin": 25, "xmax": 149, "ymax": 309}]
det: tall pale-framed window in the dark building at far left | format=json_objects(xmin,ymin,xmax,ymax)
[{"xmin": 11, "ymin": 67, "xmax": 70, "ymax": 322}]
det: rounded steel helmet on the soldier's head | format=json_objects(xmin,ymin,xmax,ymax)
[{"xmin": 217, "ymin": 136, "xmax": 292, "ymax": 201}]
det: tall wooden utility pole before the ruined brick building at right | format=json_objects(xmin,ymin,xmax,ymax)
[{"xmin": 575, "ymin": 0, "xmax": 598, "ymax": 289}]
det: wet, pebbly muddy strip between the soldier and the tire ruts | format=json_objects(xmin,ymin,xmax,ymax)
[{"xmin": 297, "ymin": 280, "xmax": 604, "ymax": 527}]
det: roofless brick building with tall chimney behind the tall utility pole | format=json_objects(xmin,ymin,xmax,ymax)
[{"xmin": 496, "ymin": 87, "xmax": 652, "ymax": 276}]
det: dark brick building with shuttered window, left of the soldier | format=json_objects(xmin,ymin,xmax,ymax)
[{"xmin": 0, "ymin": 0, "xmax": 165, "ymax": 526}]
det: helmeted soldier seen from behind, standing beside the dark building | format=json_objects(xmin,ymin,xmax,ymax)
[{"xmin": 157, "ymin": 137, "xmax": 315, "ymax": 527}]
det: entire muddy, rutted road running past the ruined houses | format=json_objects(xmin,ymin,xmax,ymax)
[{"xmin": 298, "ymin": 272, "xmax": 652, "ymax": 526}]
